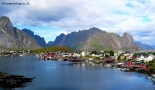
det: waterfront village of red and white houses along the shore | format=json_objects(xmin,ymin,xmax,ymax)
[{"xmin": 0, "ymin": 50, "xmax": 155, "ymax": 70}]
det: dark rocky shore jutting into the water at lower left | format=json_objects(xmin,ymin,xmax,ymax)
[{"xmin": 0, "ymin": 72, "xmax": 34, "ymax": 89}]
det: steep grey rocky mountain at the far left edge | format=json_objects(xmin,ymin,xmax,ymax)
[{"xmin": 0, "ymin": 16, "xmax": 41, "ymax": 49}]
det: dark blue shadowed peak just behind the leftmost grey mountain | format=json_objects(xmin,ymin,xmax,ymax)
[{"xmin": 22, "ymin": 29, "xmax": 46, "ymax": 47}]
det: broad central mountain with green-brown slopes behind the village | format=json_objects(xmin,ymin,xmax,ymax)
[{"xmin": 49, "ymin": 27, "xmax": 139, "ymax": 51}]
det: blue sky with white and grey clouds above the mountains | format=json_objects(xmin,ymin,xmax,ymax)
[{"xmin": 0, "ymin": 0, "xmax": 155, "ymax": 45}]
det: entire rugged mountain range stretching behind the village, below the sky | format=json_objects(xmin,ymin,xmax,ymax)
[{"xmin": 0, "ymin": 16, "xmax": 149, "ymax": 52}]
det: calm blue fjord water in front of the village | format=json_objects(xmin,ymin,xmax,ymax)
[{"xmin": 0, "ymin": 56, "xmax": 154, "ymax": 90}]
